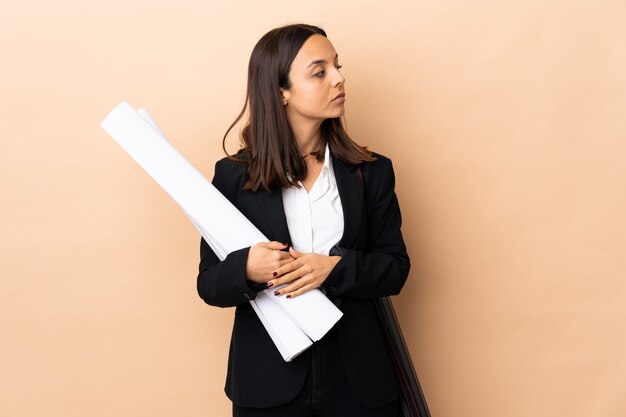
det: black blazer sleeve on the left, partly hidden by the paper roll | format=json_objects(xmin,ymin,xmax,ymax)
[{"xmin": 197, "ymin": 160, "xmax": 267, "ymax": 307}]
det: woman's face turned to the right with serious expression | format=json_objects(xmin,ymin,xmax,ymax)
[{"xmin": 281, "ymin": 34, "xmax": 346, "ymax": 123}]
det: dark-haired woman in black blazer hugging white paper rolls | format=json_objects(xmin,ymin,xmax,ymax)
[{"xmin": 198, "ymin": 24, "xmax": 410, "ymax": 417}]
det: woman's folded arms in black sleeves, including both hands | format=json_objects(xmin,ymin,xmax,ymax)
[{"xmin": 198, "ymin": 159, "xmax": 410, "ymax": 307}]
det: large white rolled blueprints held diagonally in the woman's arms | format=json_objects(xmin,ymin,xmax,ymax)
[{"xmin": 101, "ymin": 102, "xmax": 342, "ymax": 361}]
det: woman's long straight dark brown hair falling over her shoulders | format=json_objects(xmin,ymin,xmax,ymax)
[{"xmin": 222, "ymin": 24, "xmax": 376, "ymax": 191}]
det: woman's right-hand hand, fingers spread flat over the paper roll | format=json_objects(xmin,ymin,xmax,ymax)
[{"xmin": 267, "ymin": 248, "xmax": 341, "ymax": 298}]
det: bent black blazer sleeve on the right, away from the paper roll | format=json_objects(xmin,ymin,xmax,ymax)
[{"xmin": 322, "ymin": 156, "xmax": 411, "ymax": 298}]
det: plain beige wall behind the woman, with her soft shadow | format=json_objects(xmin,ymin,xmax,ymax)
[{"xmin": 0, "ymin": 0, "xmax": 626, "ymax": 417}]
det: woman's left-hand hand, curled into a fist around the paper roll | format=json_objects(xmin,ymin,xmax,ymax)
[{"xmin": 246, "ymin": 242, "xmax": 293, "ymax": 284}]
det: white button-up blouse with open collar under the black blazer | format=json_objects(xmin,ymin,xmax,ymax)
[{"xmin": 282, "ymin": 144, "xmax": 343, "ymax": 255}]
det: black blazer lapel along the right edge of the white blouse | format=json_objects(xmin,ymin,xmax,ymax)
[{"xmin": 332, "ymin": 158, "xmax": 365, "ymax": 248}]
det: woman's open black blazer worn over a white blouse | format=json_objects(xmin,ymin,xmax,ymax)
[{"xmin": 197, "ymin": 150, "xmax": 410, "ymax": 408}]
